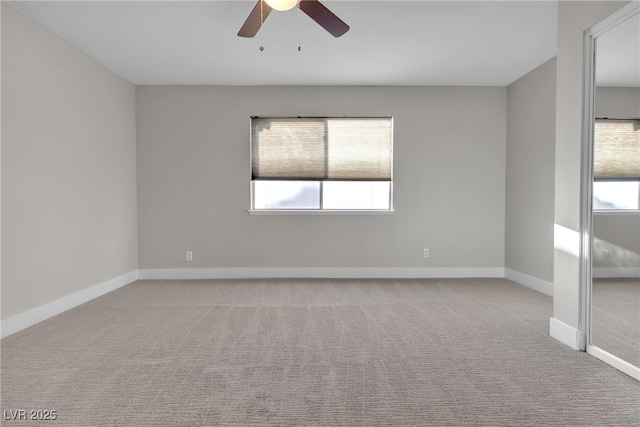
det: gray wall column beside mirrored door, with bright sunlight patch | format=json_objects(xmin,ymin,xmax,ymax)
[{"xmin": 553, "ymin": 1, "xmax": 628, "ymax": 329}]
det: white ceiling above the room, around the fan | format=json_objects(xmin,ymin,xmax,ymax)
[{"xmin": 11, "ymin": 0, "xmax": 557, "ymax": 86}]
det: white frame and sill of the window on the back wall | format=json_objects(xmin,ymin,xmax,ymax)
[{"xmin": 248, "ymin": 115, "xmax": 395, "ymax": 215}]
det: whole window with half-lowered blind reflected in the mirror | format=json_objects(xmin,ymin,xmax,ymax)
[{"xmin": 593, "ymin": 119, "xmax": 640, "ymax": 211}]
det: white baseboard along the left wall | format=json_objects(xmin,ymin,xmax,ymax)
[{"xmin": 0, "ymin": 270, "xmax": 138, "ymax": 338}]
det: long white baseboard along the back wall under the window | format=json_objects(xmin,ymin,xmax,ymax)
[{"xmin": 139, "ymin": 267, "xmax": 504, "ymax": 280}]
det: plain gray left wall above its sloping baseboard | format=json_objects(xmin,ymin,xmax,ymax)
[{"xmin": 1, "ymin": 2, "xmax": 137, "ymax": 319}]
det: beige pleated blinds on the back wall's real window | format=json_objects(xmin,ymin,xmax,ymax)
[{"xmin": 251, "ymin": 117, "xmax": 392, "ymax": 181}]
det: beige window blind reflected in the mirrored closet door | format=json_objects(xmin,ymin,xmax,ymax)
[{"xmin": 593, "ymin": 119, "xmax": 640, "ymax": 180}]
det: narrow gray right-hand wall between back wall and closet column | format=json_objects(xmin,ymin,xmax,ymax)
[{"xmin": 505, "ymin": 58, "xmax": 556, "ymax": 282}]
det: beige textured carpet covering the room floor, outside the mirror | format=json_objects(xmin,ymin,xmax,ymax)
[{"xmin": 1, "ymin": 279, "xmax": 640, "ymax": 426}]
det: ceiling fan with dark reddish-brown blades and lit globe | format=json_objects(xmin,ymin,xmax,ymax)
[{"xmin": 238, "ymin": 0, "xmax": 349, "ymax": 37}]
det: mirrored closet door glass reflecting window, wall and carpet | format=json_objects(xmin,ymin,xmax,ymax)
[{"xmin": 590, "ymin": 10, "xmax": 640, "ymax": 366}]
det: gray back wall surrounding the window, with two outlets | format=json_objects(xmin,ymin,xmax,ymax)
[{"xmin": 136, "ymin": 86, "xmax": 506, "ymax": 269}]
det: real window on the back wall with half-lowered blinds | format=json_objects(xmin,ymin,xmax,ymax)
[{"xmin": 251, "ymin": 117, "xmax": 393, "ymax": 211}]
